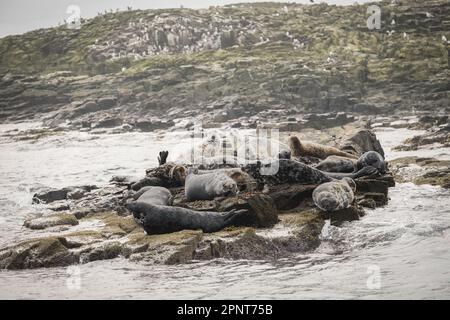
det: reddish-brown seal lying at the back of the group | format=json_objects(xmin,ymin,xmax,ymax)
[{"xmin": 289, "ymin": 136, "xmax": 356, "ymax": 159}]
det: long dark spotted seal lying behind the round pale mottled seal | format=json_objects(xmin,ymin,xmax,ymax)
[{"xmin": 242, "ymin": 159, "xmax": 378, "ymax": 185}]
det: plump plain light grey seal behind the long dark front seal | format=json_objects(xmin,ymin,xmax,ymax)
[{"xmin": 184, "ymin": 168, "xmax": 239, "ymax": 201}]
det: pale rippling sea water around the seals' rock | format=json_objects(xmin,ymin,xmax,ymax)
[{"xmin": 0, "ymin": 124, "xmax": 450, "ymax": 299}]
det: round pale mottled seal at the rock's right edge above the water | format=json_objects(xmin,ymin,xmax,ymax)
[{"xmin": 312, "ymin": 178, "xmax": 356, "ymax": 212}]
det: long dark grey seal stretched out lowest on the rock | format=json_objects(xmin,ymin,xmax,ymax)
[{"xmin": 127, "ymin": 202, "xmax": 247, "ymax": 234}]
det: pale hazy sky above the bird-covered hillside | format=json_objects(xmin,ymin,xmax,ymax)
[{"xmin": 0, "ymin": 0, "xmax": 376, "ymax": 37}]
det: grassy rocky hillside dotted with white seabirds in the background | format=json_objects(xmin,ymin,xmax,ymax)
[{"xmin": 0, "ymin": 0, "xmax": 450, "ymax": 131}]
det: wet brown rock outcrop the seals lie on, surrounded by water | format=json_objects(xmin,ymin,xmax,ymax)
[{"xmin": 0, "ymin": 125, "xmax": 396, "ymax": 269}]
